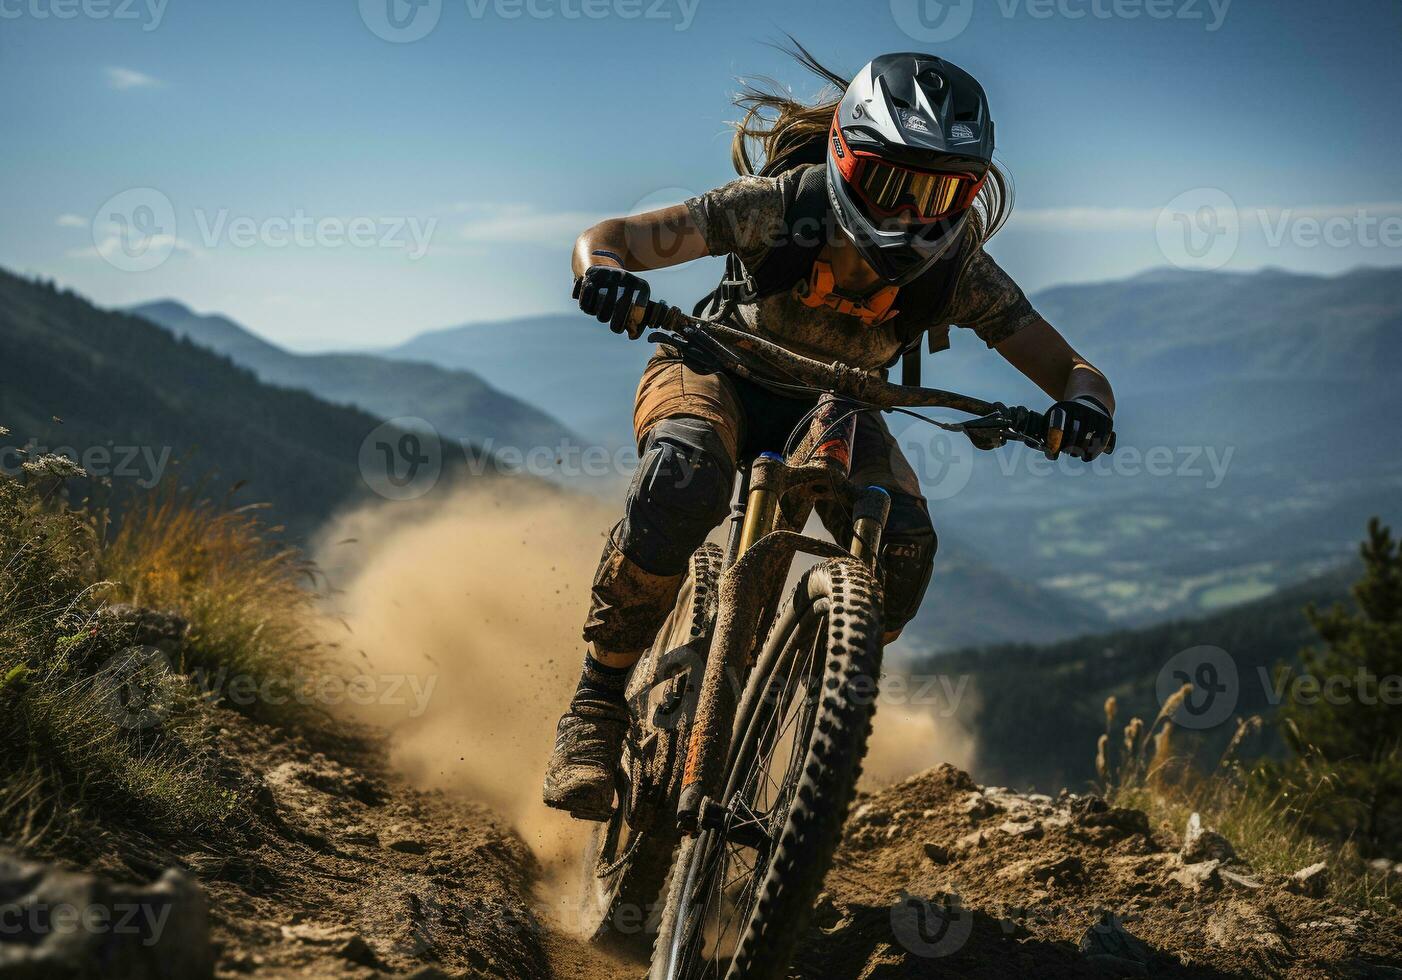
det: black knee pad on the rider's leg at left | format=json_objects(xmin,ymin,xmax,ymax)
[{"xmin": 614, "ymin": 419, "xmax": 735, "ymax": 575}]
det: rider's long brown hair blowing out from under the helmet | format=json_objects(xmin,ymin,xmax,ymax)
[{"xmin": 730, "ymin": 38, "xmax": 1016, "ymax": 240}]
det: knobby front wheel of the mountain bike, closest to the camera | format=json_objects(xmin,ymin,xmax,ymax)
[{"xmin": 651, "ymin": 558, "xmax": 882, "ymax": 980}]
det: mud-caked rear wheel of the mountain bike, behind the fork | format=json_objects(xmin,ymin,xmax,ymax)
[{"xmin": 580, "ymin": 544, "xmax": 723, "ymax": 960}]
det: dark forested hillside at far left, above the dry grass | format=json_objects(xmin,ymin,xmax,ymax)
[{"xmin": 0, "ymin": 271, "xmax": 454, "ymax": 534}]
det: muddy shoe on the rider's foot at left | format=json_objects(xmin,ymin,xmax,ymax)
[{"xmin": 544, "ymin": 701, "xmax": 628, "ymax": 820}]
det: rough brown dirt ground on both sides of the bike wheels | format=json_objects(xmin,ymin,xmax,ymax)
[{"xmin": 189, "ymin": 715, "xmax": 1402, "ymax": 980}]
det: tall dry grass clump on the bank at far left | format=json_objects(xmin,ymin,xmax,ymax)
[{"xmin": 0, "ymin": 463, "xmax": 328, "ymax": 859}]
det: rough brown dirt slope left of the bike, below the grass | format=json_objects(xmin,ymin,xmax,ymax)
[{"xmin": 169, "ymin": 714, "xmax": 631, "ymax": 980}]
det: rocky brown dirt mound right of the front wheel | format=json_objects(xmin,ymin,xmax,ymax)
[{"xmin": 795, "ymin": 765, "xmax": 1402, "ymax": 980}]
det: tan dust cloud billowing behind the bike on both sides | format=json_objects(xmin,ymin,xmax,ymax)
[{"xmin": 315, "ymin": 485, "xmax": 973, "ymax": 925}]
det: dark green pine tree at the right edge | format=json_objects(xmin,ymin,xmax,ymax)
[{"xmin": 1281, "ymin": 517, "xmax": 1402, "ymax": 854}]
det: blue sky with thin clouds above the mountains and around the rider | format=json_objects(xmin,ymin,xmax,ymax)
[{"xmin": 0, "ymin": 0, "xmax": 1402, "ymax": 349}]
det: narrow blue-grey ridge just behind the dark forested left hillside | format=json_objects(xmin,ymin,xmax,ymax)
[{"xmin": 129, "ymin": 300, "xmax": 579, "ymax": 451}]
